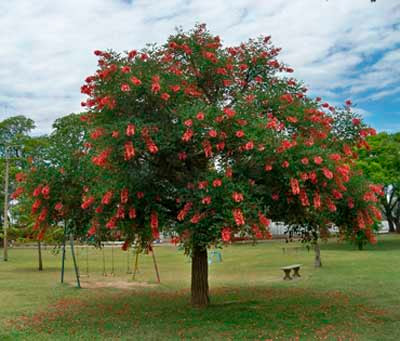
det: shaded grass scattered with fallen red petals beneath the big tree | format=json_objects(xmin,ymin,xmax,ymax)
[{"xmin": 8, "ymin": 288, "xmax": 398, "ymax": 339}]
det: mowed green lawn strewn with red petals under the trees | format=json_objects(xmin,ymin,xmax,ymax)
[{"xmin": 0, "ymin": 235, "xmax": 400, "ymax": 340}]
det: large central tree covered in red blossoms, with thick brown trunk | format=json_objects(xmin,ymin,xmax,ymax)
[{"xmin": 72, "ymin": 25, "xmax": 382, "ymax": 306}]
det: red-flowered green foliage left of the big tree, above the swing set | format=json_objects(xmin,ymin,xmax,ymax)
[{"xmin": 13, "ymin": 114, "xmax": 94, "ymax": 243}]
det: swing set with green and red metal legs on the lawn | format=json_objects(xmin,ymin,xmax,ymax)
[{"xmin": 61, "ymin": 226, "xmax": 161, "ymax": 289}]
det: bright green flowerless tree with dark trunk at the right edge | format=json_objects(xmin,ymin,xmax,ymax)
[{"xmin": 358, "ymin": 132, "xmax": 400, "ymax": 233}]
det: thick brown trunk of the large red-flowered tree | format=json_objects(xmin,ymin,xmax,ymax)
[{"xmin": 192, "ymin": 247, "xmax": 210, "ymax": 308}]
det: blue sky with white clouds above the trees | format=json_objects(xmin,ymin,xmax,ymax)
[{"xmin": 0, "ymin": 0, "xmax": 400, "ymax": 135}]
